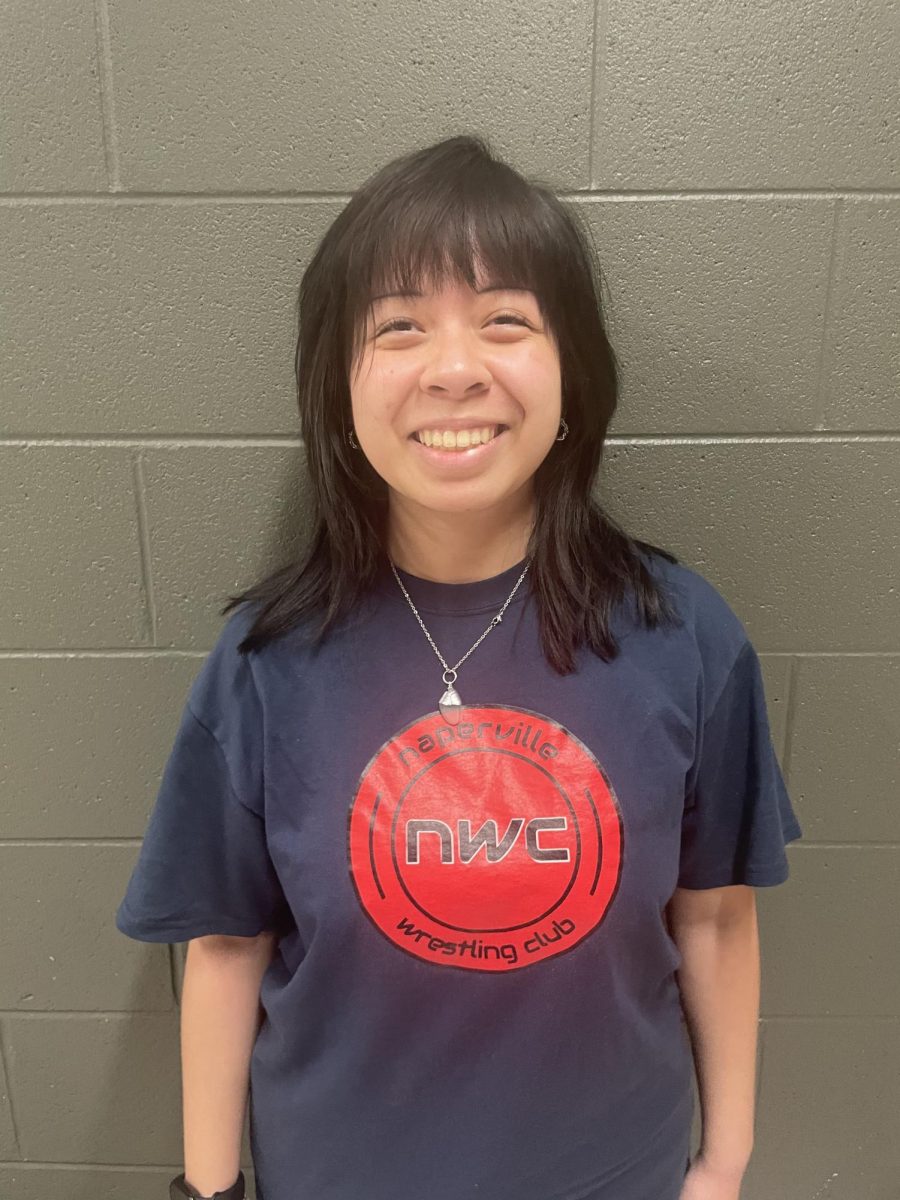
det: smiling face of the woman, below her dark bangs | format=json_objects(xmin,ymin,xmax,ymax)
[{"xmin": 350, "ymin": 270, "xmax": 562, "ymax": 532}]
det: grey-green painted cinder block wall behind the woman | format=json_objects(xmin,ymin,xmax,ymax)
[{"xmin": 0, "ymin": 0, "xmax": 900, "ymax": 1200}]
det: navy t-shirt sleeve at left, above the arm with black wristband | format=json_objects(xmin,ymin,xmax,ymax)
[{"xmin": 115, "ymin": 626, "xmax": 293, "ymax": 942}]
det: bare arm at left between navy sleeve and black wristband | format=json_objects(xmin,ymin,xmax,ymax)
[{"xmin": 181, "ymin": 934, "xmax": 275, "ymax": 1195}]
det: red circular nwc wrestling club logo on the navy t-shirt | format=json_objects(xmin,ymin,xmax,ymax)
[{"xmin": 348, "ymin": 704, "xmax": 623, "ymax": 971}]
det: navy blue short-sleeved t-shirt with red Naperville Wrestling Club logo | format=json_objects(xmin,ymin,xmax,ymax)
[{"xmin": 115, "ymin": 556, "xmax": 802, "ymax": 1200}]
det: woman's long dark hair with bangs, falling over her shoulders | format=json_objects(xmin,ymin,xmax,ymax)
[{"xmin": 222, "ymin": 136, "xmax": 678, "ymax": 674}]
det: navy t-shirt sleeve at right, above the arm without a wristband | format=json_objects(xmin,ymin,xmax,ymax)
[{"xmin": 678, "ymin": 641, "xmax": 803, "ymax": 888}]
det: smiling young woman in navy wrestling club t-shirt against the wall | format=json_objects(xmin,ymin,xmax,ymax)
[{"xmin": 116, "ymin": 137, "xmax": 802, "ymax": 1200}]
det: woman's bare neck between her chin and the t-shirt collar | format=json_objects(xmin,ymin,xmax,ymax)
[{"xmin": 389, "ymin": 487, "xmax": 534, "ymax": 583}]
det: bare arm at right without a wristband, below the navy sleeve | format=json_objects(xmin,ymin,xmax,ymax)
[{"xmin": 668, "ymin": 884, "xmax": 760, "ymax": 1177}]
